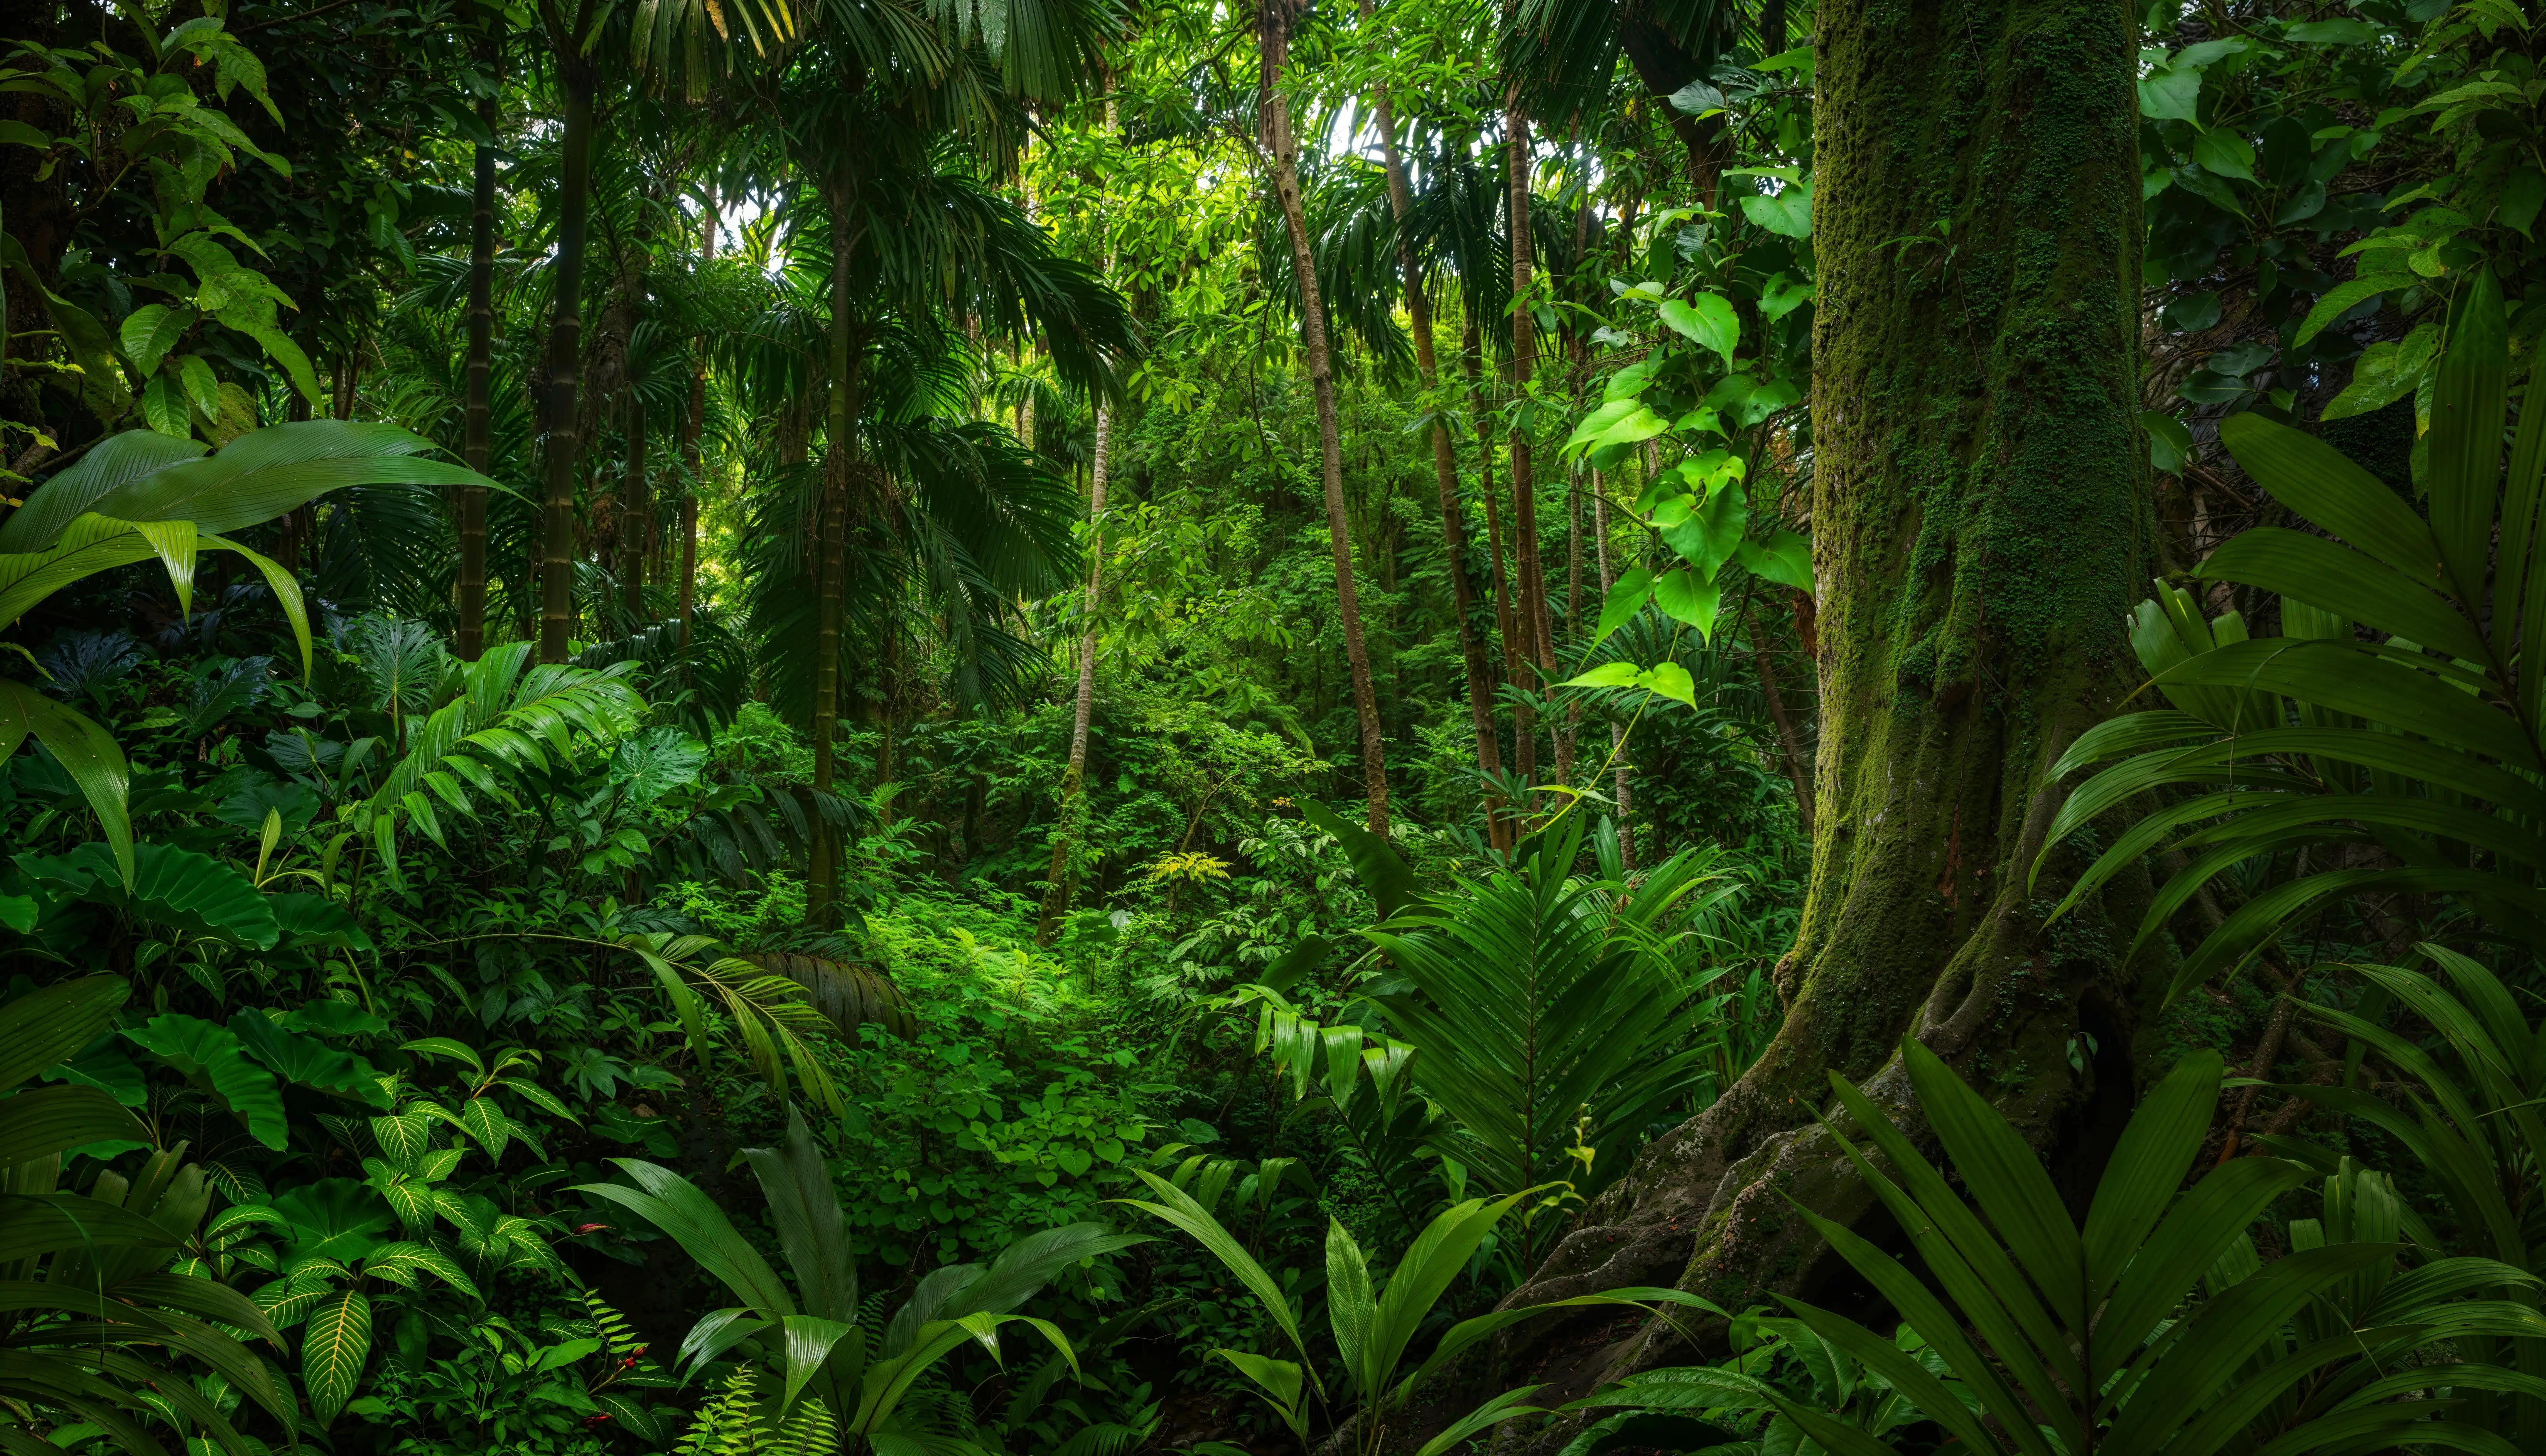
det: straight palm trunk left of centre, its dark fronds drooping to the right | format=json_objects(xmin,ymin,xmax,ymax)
[{"xmin": 805, "ymin": 168, "xmax": 858, "ymax": 929}]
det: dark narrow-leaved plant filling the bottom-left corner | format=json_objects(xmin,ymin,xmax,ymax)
[{"xmin": 0, "ymin": 975, "xmax": 298, "ymax": 1456}]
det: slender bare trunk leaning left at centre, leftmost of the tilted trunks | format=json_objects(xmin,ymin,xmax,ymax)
[{"xmin": 1255, "ymin": 11, "xmax": 1388, "ymax": 835}]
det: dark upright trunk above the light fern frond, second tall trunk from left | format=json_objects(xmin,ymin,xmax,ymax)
[{"xmin": 540, "ymin": 65, "xmax": 593, "ymax": 662}]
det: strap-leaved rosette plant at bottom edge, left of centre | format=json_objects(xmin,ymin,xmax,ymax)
[{"xmin": 573, "ymin": 1105, "xmax": 1146, "ymax": 1456}]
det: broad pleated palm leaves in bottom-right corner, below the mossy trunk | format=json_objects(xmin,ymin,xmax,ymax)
[{"xmin": 1777, "ymin": 1038, "xmax": 2546, "ymax": 1456}]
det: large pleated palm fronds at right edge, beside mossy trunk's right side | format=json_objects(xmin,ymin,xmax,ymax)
[{"xmin": 2034, "ymin": 272, "xmax": 2546, "ymax": 995}]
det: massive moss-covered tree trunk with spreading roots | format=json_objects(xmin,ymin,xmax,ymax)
[{"xmin": 1507, "ymin": 0, "xmax": 2156, "ymax": 1400}]
